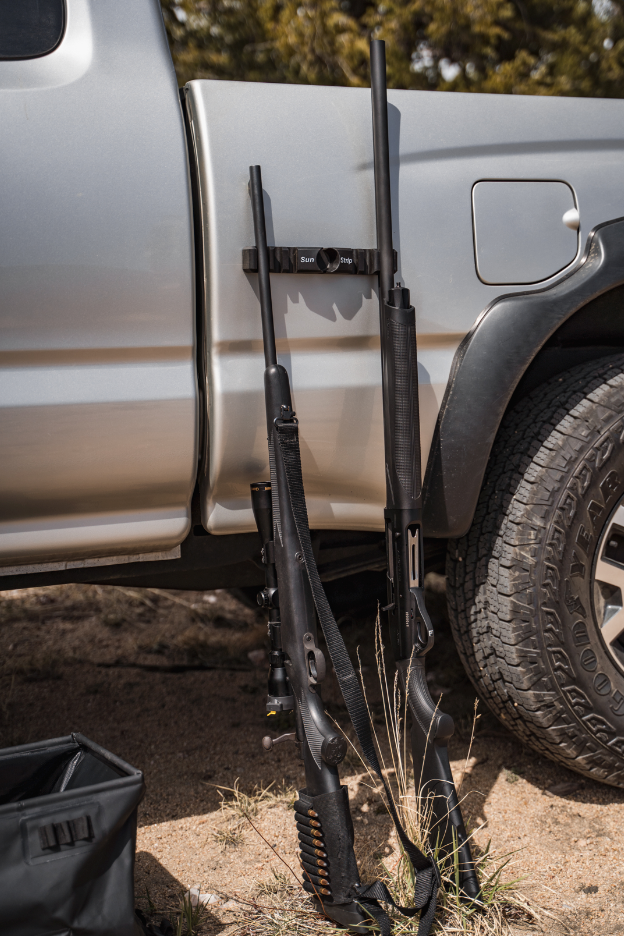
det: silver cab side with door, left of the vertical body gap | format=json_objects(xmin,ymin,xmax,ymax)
[{"xmin": 0, "ymin": 0, "xmax": 197, "ymax": 571}]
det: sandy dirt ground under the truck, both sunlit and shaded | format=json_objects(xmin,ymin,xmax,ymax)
[{"xmin": 0, "ymin": 576, "xmax": 624, "ymax": 936}]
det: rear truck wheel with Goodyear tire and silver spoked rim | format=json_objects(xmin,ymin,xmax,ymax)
[{"xmin": 447, "ymin": 354, "xmax": 624, "ymax": 787}]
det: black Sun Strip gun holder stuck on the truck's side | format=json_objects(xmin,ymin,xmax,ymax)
[{"xmin": 243, "ymin": 247, "xmax": 397, "ymax": 276}]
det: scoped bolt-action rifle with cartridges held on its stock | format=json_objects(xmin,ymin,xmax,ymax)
[{"xmin": 249, "ymin": 166, "xmax": 368, "ymax": 932}]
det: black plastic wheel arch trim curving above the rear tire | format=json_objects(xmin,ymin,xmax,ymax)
[{"xmin": 423, "ymin": 218, "xmax": 624, "ymax": 538}]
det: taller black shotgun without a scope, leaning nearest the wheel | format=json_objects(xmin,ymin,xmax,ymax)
[{"xmin": 371, "ymin": 39, "xmax": 480, "ymax": 899}]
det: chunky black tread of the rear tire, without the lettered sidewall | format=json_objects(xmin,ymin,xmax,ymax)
[{"xmin": 447, "ymin": 354, "xmax": 624, "ymax": 786}]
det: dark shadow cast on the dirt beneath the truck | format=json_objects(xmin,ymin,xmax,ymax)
[{"xmin": 0, "ymin": 576, "xmax": 622, "ymax": 824}]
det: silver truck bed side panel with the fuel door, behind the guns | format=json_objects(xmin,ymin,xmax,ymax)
[{"xmin": 188, "ymin": 81, "xmax": 624, "ymax": 533}]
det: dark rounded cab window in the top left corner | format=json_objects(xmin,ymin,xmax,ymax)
[{"xmin": 0, "ymin": 0, "xmax": 65, "ymax": 59}]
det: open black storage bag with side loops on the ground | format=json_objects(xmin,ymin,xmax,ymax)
[{"xmin": 0, "ymin": 734, "xmax": 145, "ymax": 936}]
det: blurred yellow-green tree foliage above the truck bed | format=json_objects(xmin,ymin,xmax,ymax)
[{"xmin": 162, "ymin": 0, "xmax": 624, "ymax": 97}]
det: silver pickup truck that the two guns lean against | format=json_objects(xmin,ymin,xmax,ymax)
[{"xmin": 0, "ymin": 0, "xmax": 624, "ymax": 786}]
